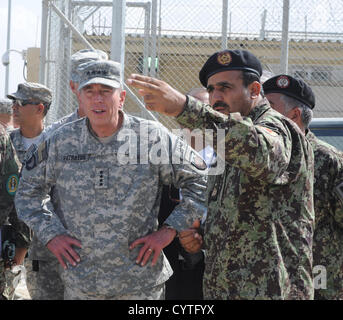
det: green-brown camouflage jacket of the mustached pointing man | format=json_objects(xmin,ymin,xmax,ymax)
[{"xmin": 177, "ymin": 97, "xmax": 314, "ymax": 299}]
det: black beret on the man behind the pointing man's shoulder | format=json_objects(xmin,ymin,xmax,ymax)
[{"xmin": 263, "ymin": 74, "xmax": 316, "ymax": 109}]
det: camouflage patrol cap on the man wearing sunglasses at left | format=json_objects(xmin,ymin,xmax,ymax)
[{"xmin": 7, "ymin": 82, "xmax": 52, "ymax": 103}]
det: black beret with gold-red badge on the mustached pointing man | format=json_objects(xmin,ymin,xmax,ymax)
[{"xmin": 199, "ymin": 50, "xmax": 262, "ymax": 87}]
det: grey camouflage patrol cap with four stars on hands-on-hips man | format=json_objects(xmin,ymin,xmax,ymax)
[{"xmin": 78, "ymin": 60, "xmax": 121, "ymax": 90}]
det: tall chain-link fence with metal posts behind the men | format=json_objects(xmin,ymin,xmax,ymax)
[{"xmin": 43, "ymin": 0, "xmax": 343, "ymax": 127}]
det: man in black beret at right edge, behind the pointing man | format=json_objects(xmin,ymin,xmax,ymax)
[{"xmin": 263, "ymin": 74, "xmax": 343, "ymax": 300}]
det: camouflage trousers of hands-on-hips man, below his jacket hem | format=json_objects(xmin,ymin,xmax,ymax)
[{"xmin": 64, "ymin": 283, "xmax": 165, "ymax": 300}]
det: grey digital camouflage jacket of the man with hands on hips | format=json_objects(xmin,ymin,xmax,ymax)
[{"xmin": 16, "ymin": 114, "xmax": 207, "ymax": 296}]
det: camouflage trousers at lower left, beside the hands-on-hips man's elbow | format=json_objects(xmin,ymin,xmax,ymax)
[{"xmin": 25, "ymin": 259, "xmax": 64, "ymax": 300}]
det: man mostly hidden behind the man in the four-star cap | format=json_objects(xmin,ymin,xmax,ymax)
[{"xmin": 48, "ymin": 49, "xmax": 108, "ymax": 132}]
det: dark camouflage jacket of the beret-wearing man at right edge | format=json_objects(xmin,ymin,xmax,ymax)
[{"xmin": 306, "ymin": 131, "xmax": 343, "ymax": 300}]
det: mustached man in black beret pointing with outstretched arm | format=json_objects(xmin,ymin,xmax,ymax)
[{"xmin": 128, "ymin": 50, "xmax": 314, "ymax": 299}]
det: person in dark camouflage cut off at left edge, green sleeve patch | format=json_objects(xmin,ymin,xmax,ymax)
[{"xmin": 0, "ymin": 124, "xmax": 30, "ymax": 300}]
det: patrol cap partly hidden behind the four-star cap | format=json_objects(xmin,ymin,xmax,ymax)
[{"xmin": 70, "ymin": 49, "xmax": 108, "ymax": 83}]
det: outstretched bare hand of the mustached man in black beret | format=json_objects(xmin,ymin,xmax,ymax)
[{"xmin": 126, "ymin": 74, "xmax": 186, "ymax": 117}]
